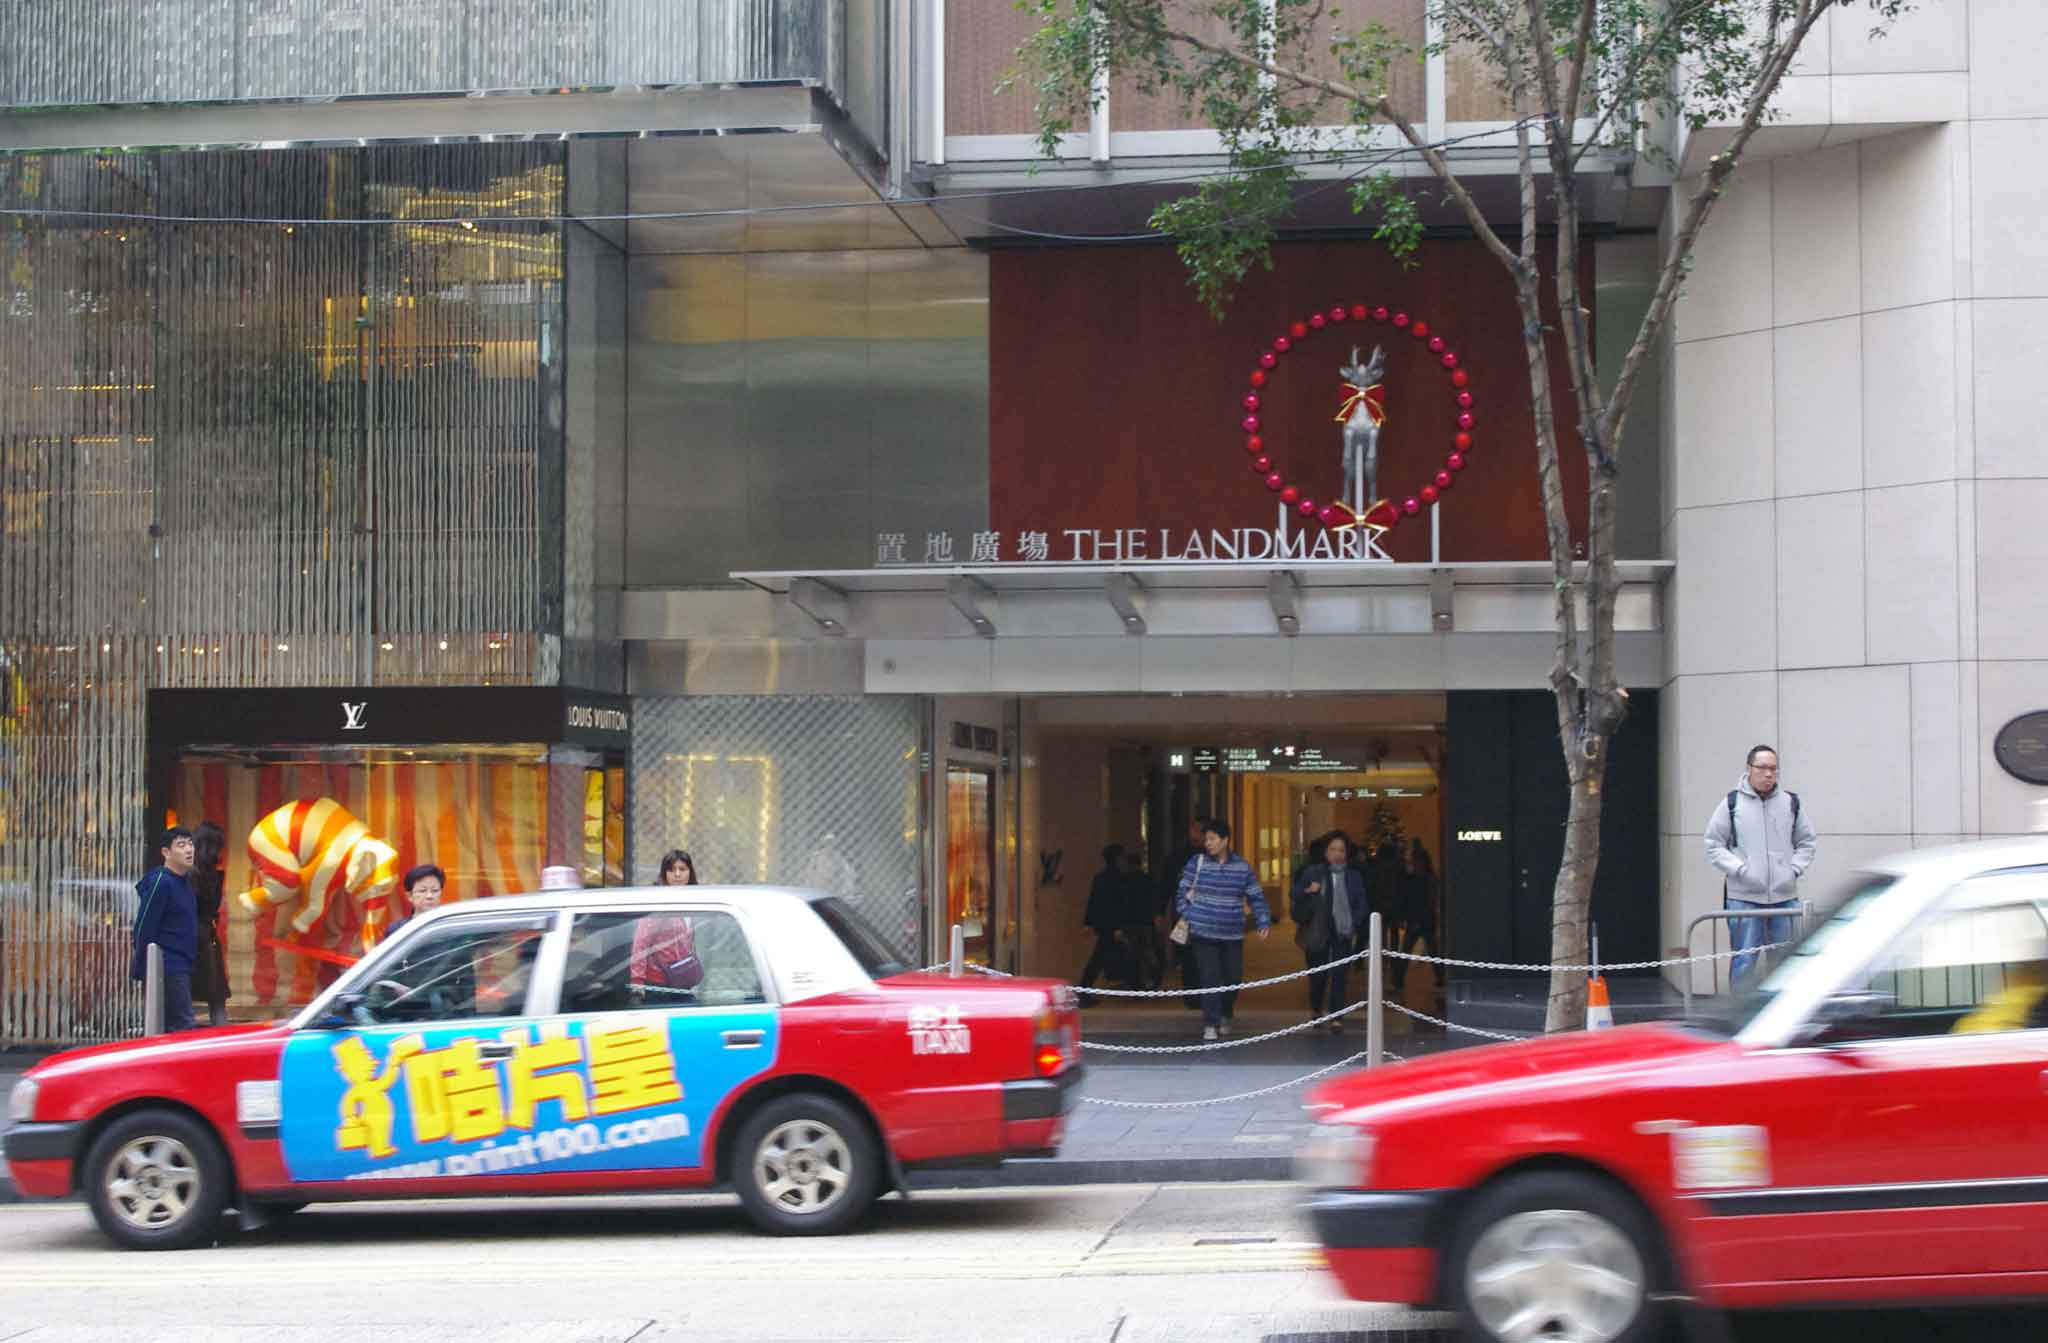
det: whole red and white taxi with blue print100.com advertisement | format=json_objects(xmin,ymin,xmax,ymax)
[{"xmin": 4, "ymin": 886, "xmax": 1081, "ymax": 1249}]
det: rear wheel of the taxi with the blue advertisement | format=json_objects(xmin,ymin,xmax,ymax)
[{"xmin": 733, "ymin": 1093, "xmax": 881, "ymax": 1237}]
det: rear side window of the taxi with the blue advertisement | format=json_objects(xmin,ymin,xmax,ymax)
[{"xmin": 561, "ymin": 909, "xmax": 768, "ymax": 1011}]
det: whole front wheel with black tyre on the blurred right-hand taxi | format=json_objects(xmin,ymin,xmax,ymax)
[{"xmin": 1444, "ymin": 1171, "xmax": 1667, "ymax": 1343}]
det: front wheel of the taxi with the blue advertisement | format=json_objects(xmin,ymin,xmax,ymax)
[{"xmin": 80, "ymin": 1110, "xmax": 227, "ymax": 1249}]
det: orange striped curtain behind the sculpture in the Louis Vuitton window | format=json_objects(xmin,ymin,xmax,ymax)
[{"xmin": 172, "ymin": 760, "xmax": 547, "ymax": 1015}]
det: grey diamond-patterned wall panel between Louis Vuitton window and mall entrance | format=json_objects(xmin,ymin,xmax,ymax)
[{"xmin": 629, "ymin": 696, "xmax": 924, "ymax": 956}]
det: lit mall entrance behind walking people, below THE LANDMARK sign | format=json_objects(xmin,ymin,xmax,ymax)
[{"xmin": 1020, "ymin": 694, "xmax": 1450, "ymax": 1017}]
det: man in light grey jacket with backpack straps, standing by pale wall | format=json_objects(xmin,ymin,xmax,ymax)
[{"xmin": 1706, "ymin": 745, "xmax": 1819, "ymax": 985}]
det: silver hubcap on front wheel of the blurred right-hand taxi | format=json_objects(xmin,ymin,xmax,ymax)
[{"xmin": 1464, "ymin": 1208, "xmax": 1645, "ymax": 1343}]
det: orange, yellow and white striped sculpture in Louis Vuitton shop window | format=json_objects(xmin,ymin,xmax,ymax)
[{"xmin": 242, "ymin": 798, "xmax": 397, "ymax": 948}]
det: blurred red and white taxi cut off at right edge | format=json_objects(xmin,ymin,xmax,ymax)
[{"xmin": 1300, "ymin": 839, "xmax": 2048, "ymax": 1343}]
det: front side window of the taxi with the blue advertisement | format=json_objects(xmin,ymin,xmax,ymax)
[{"xmin": 362, "ymin": 915, "xmax": 553, "ymax": 1026}]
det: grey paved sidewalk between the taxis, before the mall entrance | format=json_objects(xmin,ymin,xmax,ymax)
[{"xmin": 0, "ymin": 1001, "xmax": 1446, "ymax": 1204}]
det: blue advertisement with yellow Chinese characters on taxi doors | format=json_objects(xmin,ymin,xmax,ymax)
[{"xmin": 281, "ymin": 1007, "xmax": 776, "ymax": 1181}]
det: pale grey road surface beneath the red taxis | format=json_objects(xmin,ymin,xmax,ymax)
[{"xmin": 0, "ymin": 1183, "xmax": 2048, "ymax": 1343}]
